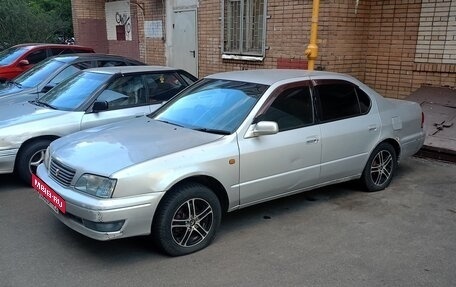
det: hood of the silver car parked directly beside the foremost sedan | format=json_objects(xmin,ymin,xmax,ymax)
[{"xmin": 0, "ymin": 100, "xmax": 67, "ymax": 128}]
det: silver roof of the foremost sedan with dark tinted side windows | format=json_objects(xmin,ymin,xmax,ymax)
[{"xmin": 206, "ymin": 69, "xmax": 352, "ymax": 85}]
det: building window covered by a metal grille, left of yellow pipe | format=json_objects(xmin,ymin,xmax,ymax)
[{"xmin": 222, "ymin": 0, "xmax": 267, "ymax": 57}]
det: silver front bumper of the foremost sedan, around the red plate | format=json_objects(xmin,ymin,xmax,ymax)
[{"xmin": 37, "ymin": 164, "xmax": 164, "ymax": 240}]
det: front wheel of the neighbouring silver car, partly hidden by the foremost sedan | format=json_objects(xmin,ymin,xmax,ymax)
[{"xmin": 15, "ymin": 140, "xmax": 51, "ymax": 185}]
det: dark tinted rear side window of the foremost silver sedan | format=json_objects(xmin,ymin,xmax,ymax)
[{"xmin": 315, "ymin": 81, "xmax": 370, "ymax": 122}]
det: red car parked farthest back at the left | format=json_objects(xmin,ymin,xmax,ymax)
[{"xmin": 0, "ymin": 44, "xmax": 94, "ymax": 81}]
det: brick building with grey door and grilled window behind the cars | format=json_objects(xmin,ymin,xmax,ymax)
[{"xmin": 72, "ymin": 0, "xmax": 456, "ymax": 98}]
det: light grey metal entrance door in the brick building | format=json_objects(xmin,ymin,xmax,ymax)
[{"xmin": 170, "ymin": 10, "xmax": 198, "ymax": 77}]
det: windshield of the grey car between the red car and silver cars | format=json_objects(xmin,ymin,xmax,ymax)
[{"xmin": 13, "ymin": 59, "xmax": 65, "ymax": 88}]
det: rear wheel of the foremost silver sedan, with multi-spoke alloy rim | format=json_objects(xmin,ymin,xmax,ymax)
[{"xmin": 361, "ymin": 142, "xmax": 397, "ymax": 192}]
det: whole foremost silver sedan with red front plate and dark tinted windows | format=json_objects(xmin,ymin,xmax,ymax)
[{"xmin": 32, "ymin": 70, "xmax": 425, "ymax": 255}]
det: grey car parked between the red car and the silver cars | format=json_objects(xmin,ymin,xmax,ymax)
[{"xmin": 0, "ymin": 53, "xmax": 146, "ymax": 105}]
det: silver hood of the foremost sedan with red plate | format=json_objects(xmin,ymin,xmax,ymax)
[{"xmin": 52, "ymin": 116, "xmax": 223, "ymax": 176}]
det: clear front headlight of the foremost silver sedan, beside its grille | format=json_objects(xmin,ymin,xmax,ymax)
[{"xmin": 74, "ymin": 173, "xmax": 117, "ymax": 198}]
